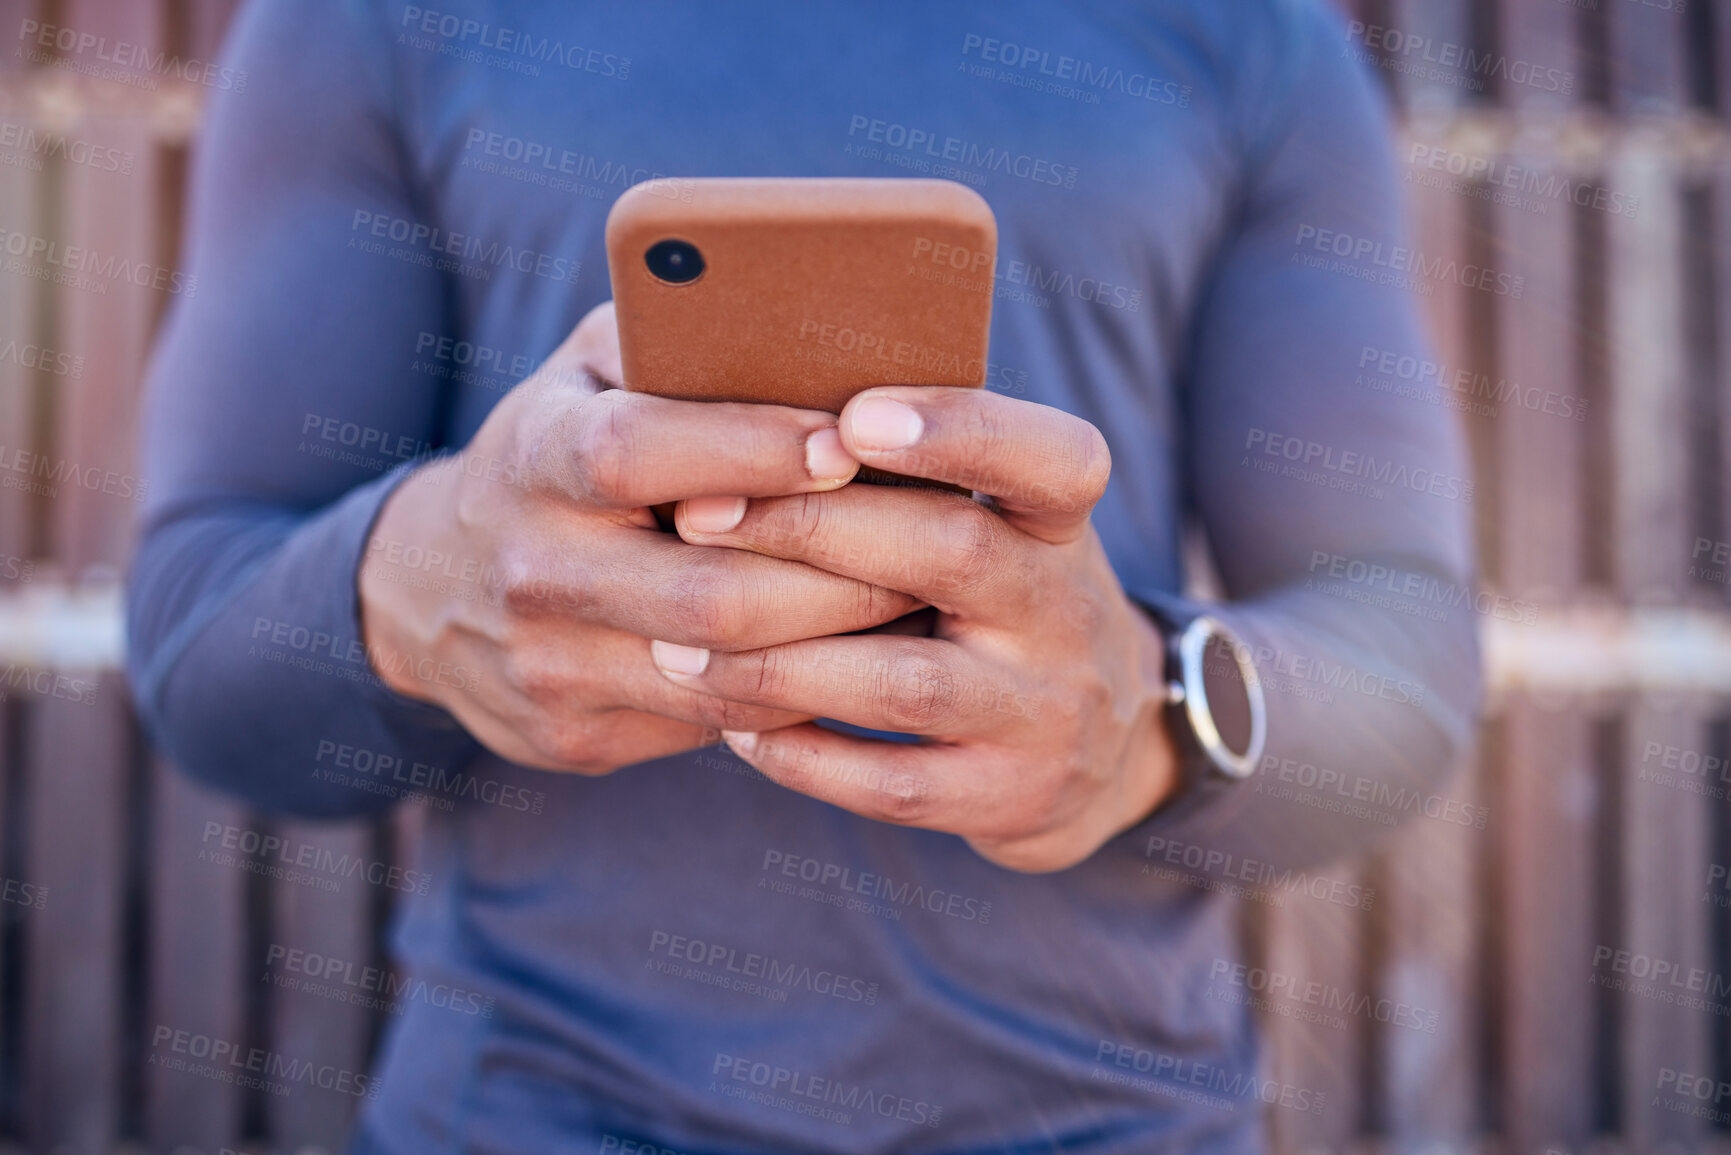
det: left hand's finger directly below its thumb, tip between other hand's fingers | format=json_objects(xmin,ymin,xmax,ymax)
[{"xmin": 574, "ymin": 532, "xmax": 919, "ymax": 651}]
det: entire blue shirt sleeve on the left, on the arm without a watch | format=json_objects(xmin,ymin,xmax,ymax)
[{"xmin": 126, "ymin": 0, "xmax": 476, "ymax": 817}]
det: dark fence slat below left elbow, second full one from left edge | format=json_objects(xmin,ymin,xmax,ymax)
[{"xmin": 145, "ymin": 762, "xmax": 247, "ymax": 1152}]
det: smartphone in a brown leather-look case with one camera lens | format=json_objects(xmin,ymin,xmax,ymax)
[{"xmin": 608, "ymin": 177, "xmax": 997, "ymax": 498}]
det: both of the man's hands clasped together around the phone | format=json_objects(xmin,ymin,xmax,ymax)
[{"xmin": 362, "ymin": 306, "xmax": 1175, "ymax": 871}]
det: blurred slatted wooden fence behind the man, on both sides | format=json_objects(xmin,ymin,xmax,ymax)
[{"xmin": 0, "ymin": 0, "xmax": 1731, "ymax": 1155}]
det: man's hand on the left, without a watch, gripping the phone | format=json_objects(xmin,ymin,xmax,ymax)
[{"xmin": 358, "ymin": 303, "xmax": 919, "ymax": 774}]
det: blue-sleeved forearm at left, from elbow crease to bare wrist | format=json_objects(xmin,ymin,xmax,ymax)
[{"xmin": 128, "ymin": 464, "xmax": 474, "ymax": 817}]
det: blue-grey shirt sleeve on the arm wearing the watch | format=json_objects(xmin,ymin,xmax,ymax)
[{"xmin": 1130, "ymin": 3, "xmax": 1481, "ymax": 874}]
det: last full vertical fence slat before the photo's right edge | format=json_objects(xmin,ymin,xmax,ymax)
[{"xmin": 1606, "ymin": 137, "xmax": 1712, "ymax": 1143}]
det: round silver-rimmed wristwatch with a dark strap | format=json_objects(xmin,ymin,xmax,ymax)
[{"xmin": 1142, "ymin": 603, "xmax": 1269, "ymax": 786}]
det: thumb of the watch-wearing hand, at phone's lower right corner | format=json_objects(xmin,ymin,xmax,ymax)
[{"xmin": 841, "ymin": 384, "xmax": 1111, "ymax": 542}]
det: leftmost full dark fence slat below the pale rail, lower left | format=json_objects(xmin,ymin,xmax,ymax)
[{"xmin": 24, "ymin": 674, "xmax": 132, "ymax": 1152}]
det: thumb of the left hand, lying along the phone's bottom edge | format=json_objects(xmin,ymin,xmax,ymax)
[{"xmin": 523, "ymin": 388, "xmax": 859, "ymax": 509}]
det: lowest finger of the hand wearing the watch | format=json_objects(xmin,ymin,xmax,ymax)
[{"xmin": 722, "ymin": 722, "xmax": 966, "ymax": 829}]
